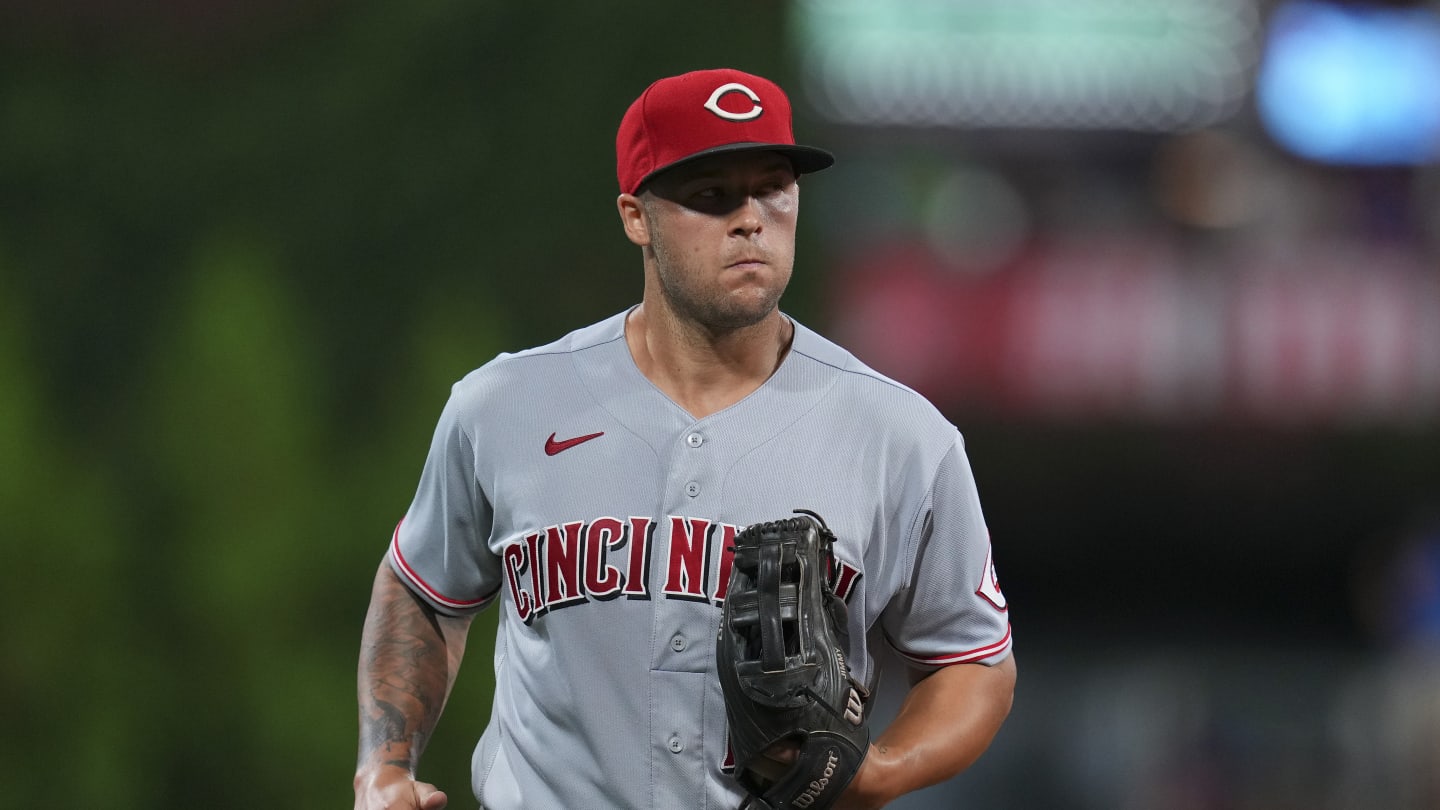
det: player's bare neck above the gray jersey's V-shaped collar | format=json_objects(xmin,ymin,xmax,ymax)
[{"xmin": 625, "ymin": 304, "xmax": 795, "ymax": 419}]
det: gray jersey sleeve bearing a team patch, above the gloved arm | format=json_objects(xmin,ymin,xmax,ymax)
[{"xmin": 880, "ymin": 432, "xmax": 1011, "ymax": 669}]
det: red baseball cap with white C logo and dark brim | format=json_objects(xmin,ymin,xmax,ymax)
[{"xmin": 615, "ymin": 68, "xmax": 835, "ymax": 195}]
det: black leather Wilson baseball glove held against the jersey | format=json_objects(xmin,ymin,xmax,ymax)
[{"xmin": 716, "ymin": 509, "xmax": 870, "ymax": 810}]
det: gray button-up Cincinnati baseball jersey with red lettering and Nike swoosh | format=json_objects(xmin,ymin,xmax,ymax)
[{"xmin": 389, "ymin": 306, "xmax": 1011, "ymax": 810}]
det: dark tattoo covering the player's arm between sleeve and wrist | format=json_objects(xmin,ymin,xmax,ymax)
[{"xmin": 357, "ymin": 565, "xmax": 454, "ymax": 773}]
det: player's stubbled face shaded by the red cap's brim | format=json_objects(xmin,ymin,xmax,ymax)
[{"xmin": 642, "ymin": 153, "xmax": 799, "ymax": 330}]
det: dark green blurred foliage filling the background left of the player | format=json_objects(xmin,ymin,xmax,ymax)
[{"xmin": 0, "ymin": 0, "xmax": 789, "ymax": 810}]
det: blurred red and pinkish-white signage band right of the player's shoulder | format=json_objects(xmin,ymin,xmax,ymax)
[{"xmin": 829, "ymin": 241, "xmax": 1440, "ymax": 424}]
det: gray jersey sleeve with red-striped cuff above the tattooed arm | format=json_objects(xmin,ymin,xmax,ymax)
[{"xmin": 389, "ymin": 383, "xmax": 501, "ymax": 615}]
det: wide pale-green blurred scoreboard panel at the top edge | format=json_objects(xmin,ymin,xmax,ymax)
[{"xmin": 793, "ymin": 0, "xmax": 1260, "ymax": 131}]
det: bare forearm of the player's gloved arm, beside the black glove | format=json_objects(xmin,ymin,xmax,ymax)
[{"xmin": 837, "ymin": 653, "xmax": 1015, "ymax": 810}]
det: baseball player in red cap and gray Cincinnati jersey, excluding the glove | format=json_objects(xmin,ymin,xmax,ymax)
[{"xmin": 354, "ymin": 69, "xmax": 1015, "ymax": 810}]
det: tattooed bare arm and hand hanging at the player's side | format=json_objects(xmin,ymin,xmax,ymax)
[{"xmin": 354, "ymin": 562, "xmax": 469, "ymax": 810}]
